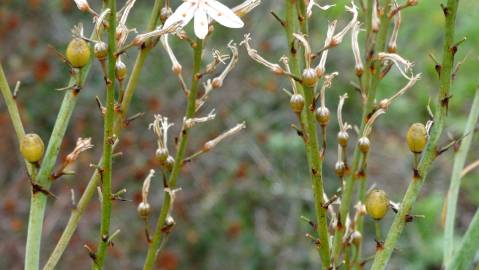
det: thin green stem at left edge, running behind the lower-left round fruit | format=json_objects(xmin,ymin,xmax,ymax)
[{"xmin": 0, "ymin": 63, "xmax": 35, "ymax": 179}]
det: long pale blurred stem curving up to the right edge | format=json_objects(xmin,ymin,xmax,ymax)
[{"xmin": 444, "ymin": 87, "xmax": 479, "ymax": 265}]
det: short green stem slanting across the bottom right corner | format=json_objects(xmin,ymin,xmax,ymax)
[{"xmin": 446, "ymin": 204, "xmax": 479, "ymax": 270}]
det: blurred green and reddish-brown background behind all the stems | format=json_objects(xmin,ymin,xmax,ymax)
[{"xmin": 0, "ymin": 0, "xmax": 479, "ymax": 269}]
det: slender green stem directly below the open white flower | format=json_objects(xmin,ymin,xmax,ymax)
[{"xmin": 143, "ymin": 39, "xmax": 203, "ymax": 270}]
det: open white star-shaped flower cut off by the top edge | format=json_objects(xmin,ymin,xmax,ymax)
[{"xmin": 163, "ymin": 0, "xmax": 244, "ymax": 39}]
